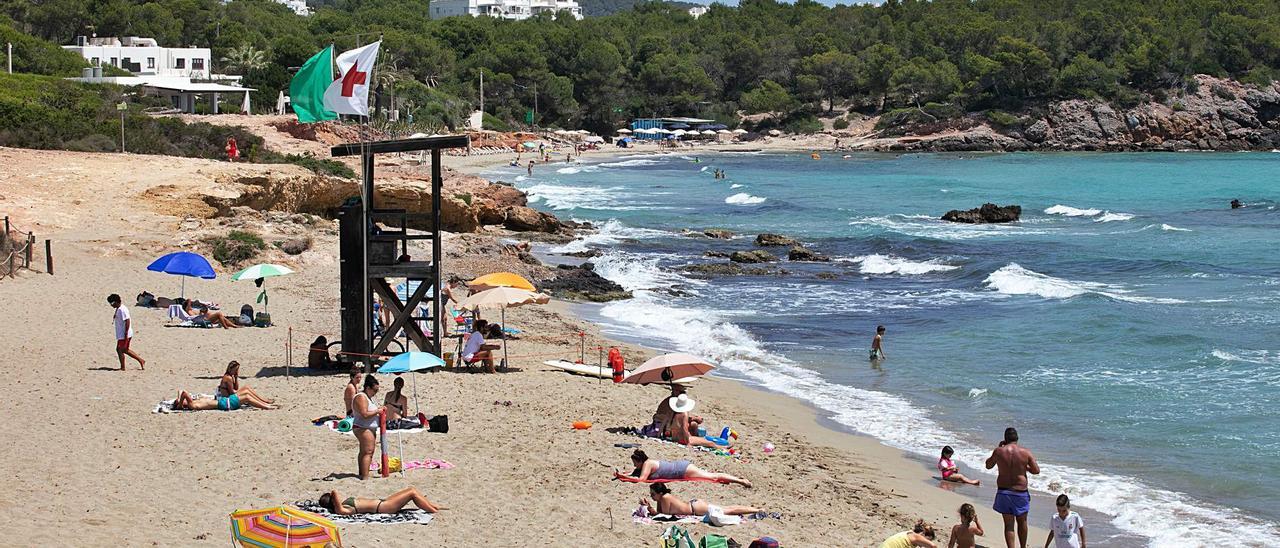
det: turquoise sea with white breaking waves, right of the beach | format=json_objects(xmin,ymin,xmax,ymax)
[{"xmin": 495, "ymin": 152, "xmax": 1280, "ymax": 545}]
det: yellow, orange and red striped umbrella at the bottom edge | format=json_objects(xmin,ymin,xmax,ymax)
[{"xmin": 232, "ymin": 506, "xmax": 342, "ymax": 548}]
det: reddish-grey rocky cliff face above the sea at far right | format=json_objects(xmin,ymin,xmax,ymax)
[{"xmin": 868, "ymin": 74, "xmax": 1280, "ymax": 151}]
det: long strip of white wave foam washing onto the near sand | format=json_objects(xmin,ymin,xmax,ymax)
[{"xmin": 600, "ymin": 292, "xmax": 1280, "ymax": 547}]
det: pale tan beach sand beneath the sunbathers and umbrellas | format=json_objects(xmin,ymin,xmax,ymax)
[{"xmin": 0, "ymin": 143, "xmax": 1047, "ymax": 547}]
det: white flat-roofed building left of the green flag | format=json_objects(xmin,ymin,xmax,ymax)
[{"xmin": 63, "ymin": 36, "xmax": 212, "ymax": 78}]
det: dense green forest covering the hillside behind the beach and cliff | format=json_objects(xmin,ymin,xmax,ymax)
[{"xmin": 0, "ymin": 0, "xmax": 1280, "ymax": 131}]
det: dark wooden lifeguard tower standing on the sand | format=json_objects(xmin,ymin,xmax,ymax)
[{"xmin": 332, "ymin": 136, "xmax": 471, "ymax": 369}]
